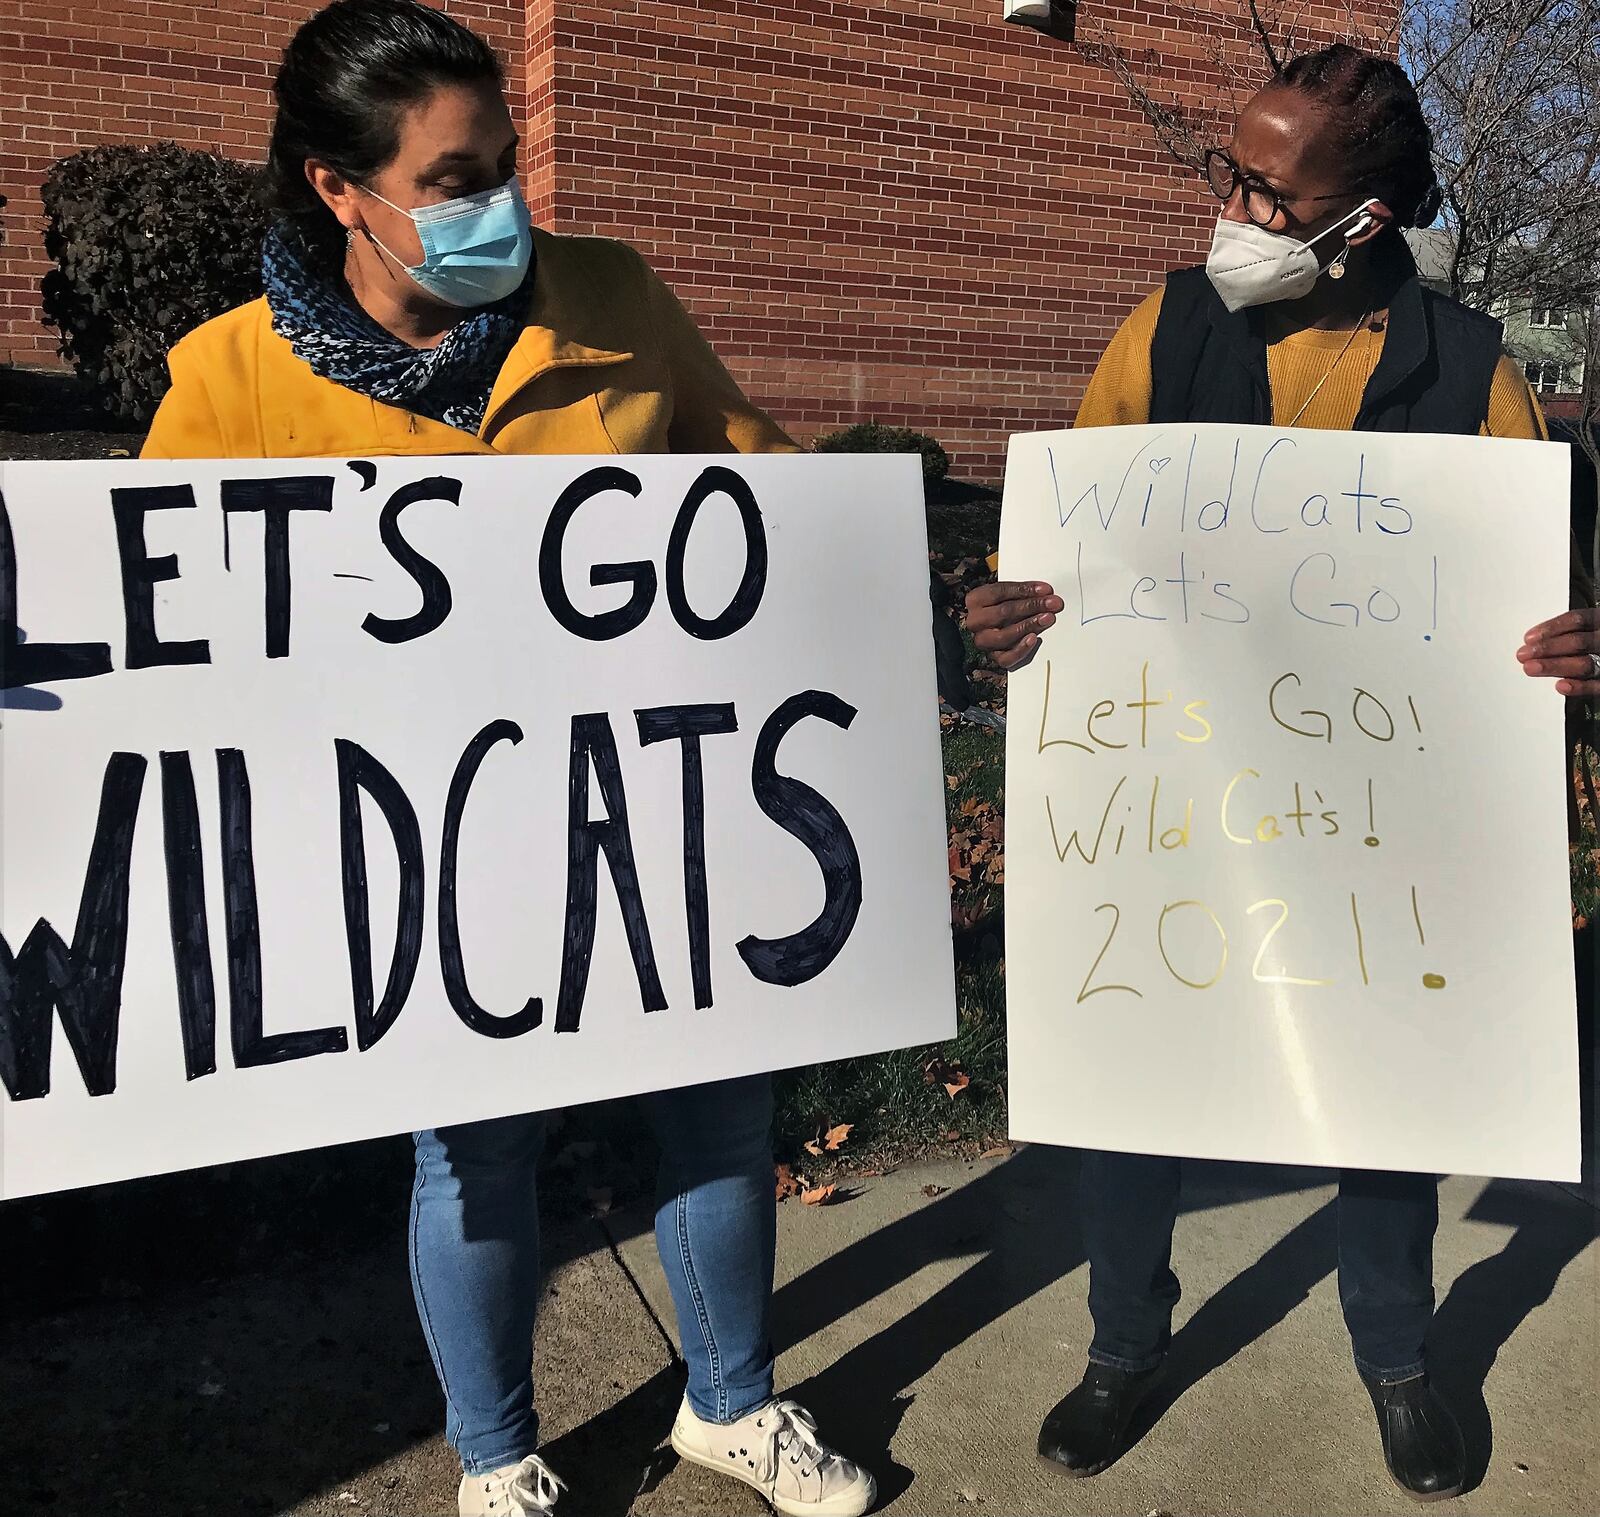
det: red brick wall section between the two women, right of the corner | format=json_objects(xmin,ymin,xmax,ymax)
[{"xmin": 537, "ymin": 0, "xmax": 1388, "ymax": 478}]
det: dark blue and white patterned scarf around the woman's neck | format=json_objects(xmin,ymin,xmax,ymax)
[{"xmin": 261, "ymin": 222, "xmax": 533, "ymax": 434}]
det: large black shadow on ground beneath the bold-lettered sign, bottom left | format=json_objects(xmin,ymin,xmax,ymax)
[{"xmin": 0, "ymin": 1138, "xmax": 617, "ymax": 1517}]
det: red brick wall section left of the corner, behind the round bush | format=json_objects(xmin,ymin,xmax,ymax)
[{"xmin": 0, "ymin": 0, "xmax": 524, "ymax": 363}]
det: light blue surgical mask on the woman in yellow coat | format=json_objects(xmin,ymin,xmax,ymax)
[{"xmin": 363, "ymin": 178, "xmax": 533, "ymax": 307}]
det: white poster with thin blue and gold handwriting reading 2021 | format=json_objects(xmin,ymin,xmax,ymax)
[{"xmin": 1000, "ymin": 426, "xmax": 1578, "ymax": 1179}]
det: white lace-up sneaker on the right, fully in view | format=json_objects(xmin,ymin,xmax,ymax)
[{"xmin": 672, "ymin": 1397, "xmax": 878, "ymax": 1517}]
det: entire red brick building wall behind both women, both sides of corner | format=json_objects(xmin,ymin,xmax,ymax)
[{"xmin": 0, "ymin": 0, "xmax": 1394, "ymax": 478}]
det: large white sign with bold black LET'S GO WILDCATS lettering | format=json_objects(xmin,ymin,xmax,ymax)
[{"xmin": 0, "ymin": 458, "xmax": 955, "ymax": 1195}]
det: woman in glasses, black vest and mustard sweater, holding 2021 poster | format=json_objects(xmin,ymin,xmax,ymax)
[{"xmin": 966, "ymin": 46, "xmax": 1600, "ymax": 1499}]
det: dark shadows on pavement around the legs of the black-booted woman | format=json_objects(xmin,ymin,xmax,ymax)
[{"xmin": 776, "ymin": 1147, "xmax": 1597, "ymax": 1503}]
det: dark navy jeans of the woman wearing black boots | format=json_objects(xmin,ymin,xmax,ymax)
[{"xmin": 1080, "ymin": 1152, "xmax": 1438, "ymax": 1379}]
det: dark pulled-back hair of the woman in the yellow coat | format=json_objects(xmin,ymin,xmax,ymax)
[{"xmin": 264, "ymin": 0, "xmax": 506, "ymax": 251}]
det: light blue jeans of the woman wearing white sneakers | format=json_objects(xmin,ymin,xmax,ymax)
[{"xmin": 411, "ymin": 1075, "xmax": 778, "ymax": 1475}]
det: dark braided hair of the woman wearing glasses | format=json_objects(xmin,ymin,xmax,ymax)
[{"xmin": 1269, "ymin": 42, "xmax": 1443, "ymax": 227}]
